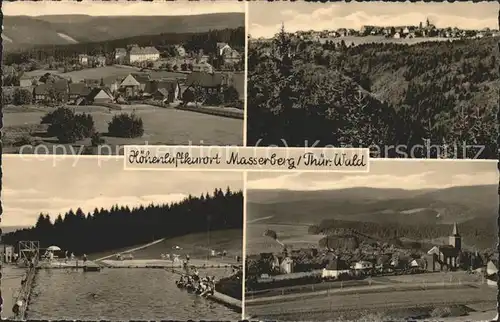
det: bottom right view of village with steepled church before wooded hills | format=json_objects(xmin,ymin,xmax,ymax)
[{"xmin": 245, "ymin": 159, "xmax": 499, "ymax": 321}]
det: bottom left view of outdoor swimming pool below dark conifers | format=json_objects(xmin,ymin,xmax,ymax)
[{"xmin": 0, "ymin": 155, "xmax": 244, "ymax": 321}]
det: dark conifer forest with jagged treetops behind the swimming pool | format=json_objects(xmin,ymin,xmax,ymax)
[{"xmin": 2, "ymin": 188, "xmax": 243, "ymax": 255}]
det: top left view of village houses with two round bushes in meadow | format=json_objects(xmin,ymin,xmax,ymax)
[{"xmin": 2, "ymin": 0, "xmax": 246, "ymax": 155}]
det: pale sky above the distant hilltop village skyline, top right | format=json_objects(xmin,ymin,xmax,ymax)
[{"xmin": 248, "ymin": 1, "xmax": 500, "ymax": 38}]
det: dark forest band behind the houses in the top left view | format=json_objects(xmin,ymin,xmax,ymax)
[{"xmin": 3, "ymin": 27, "xmax": 245, "ymax": 65}]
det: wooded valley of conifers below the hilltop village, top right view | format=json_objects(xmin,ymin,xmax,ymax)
[{"xmin": 248, "ymin": 28, "xmax": 500, "ymax": 159}]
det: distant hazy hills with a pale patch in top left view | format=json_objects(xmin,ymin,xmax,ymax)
[{"xmin": 3, "ymin": 13, "xmax": 245, "ymax": 51}]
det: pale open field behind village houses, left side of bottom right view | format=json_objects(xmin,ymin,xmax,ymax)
[{"xmin": 247, "ymin": 222, "xmax": 324, "ymax": 255}]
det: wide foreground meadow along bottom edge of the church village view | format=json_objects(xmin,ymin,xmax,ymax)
[{"xmin": 246, "ymin": 283, "xmax": 496, "ymax": 321}]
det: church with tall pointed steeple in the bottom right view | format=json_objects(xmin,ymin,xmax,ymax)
[{"xmin": 427, "ymin": 224, "xmax": 462, "ymax": 271}]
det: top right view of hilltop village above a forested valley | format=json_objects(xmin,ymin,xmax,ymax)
[{"xmin": 246, "ymin": 2, "xmax": 500, "ymax": 159}]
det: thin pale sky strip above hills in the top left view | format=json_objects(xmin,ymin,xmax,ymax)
[{"xmin": 2, "ymin": 0, "xmax": 245, "ymax": 16}]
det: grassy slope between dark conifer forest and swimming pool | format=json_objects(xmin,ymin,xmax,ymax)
[{"xmin": 89, "ymin": 229, "xmax": 243, "ymax": 262}]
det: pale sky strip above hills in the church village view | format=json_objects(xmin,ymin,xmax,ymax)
[{"xmin": 246, "ymin": 160, "xmax": 498, "ymax": 191}]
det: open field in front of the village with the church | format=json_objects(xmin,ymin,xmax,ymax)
[{"xmin": 246, "ymin": 272, "xmax": 496, "ymax": 320}]
